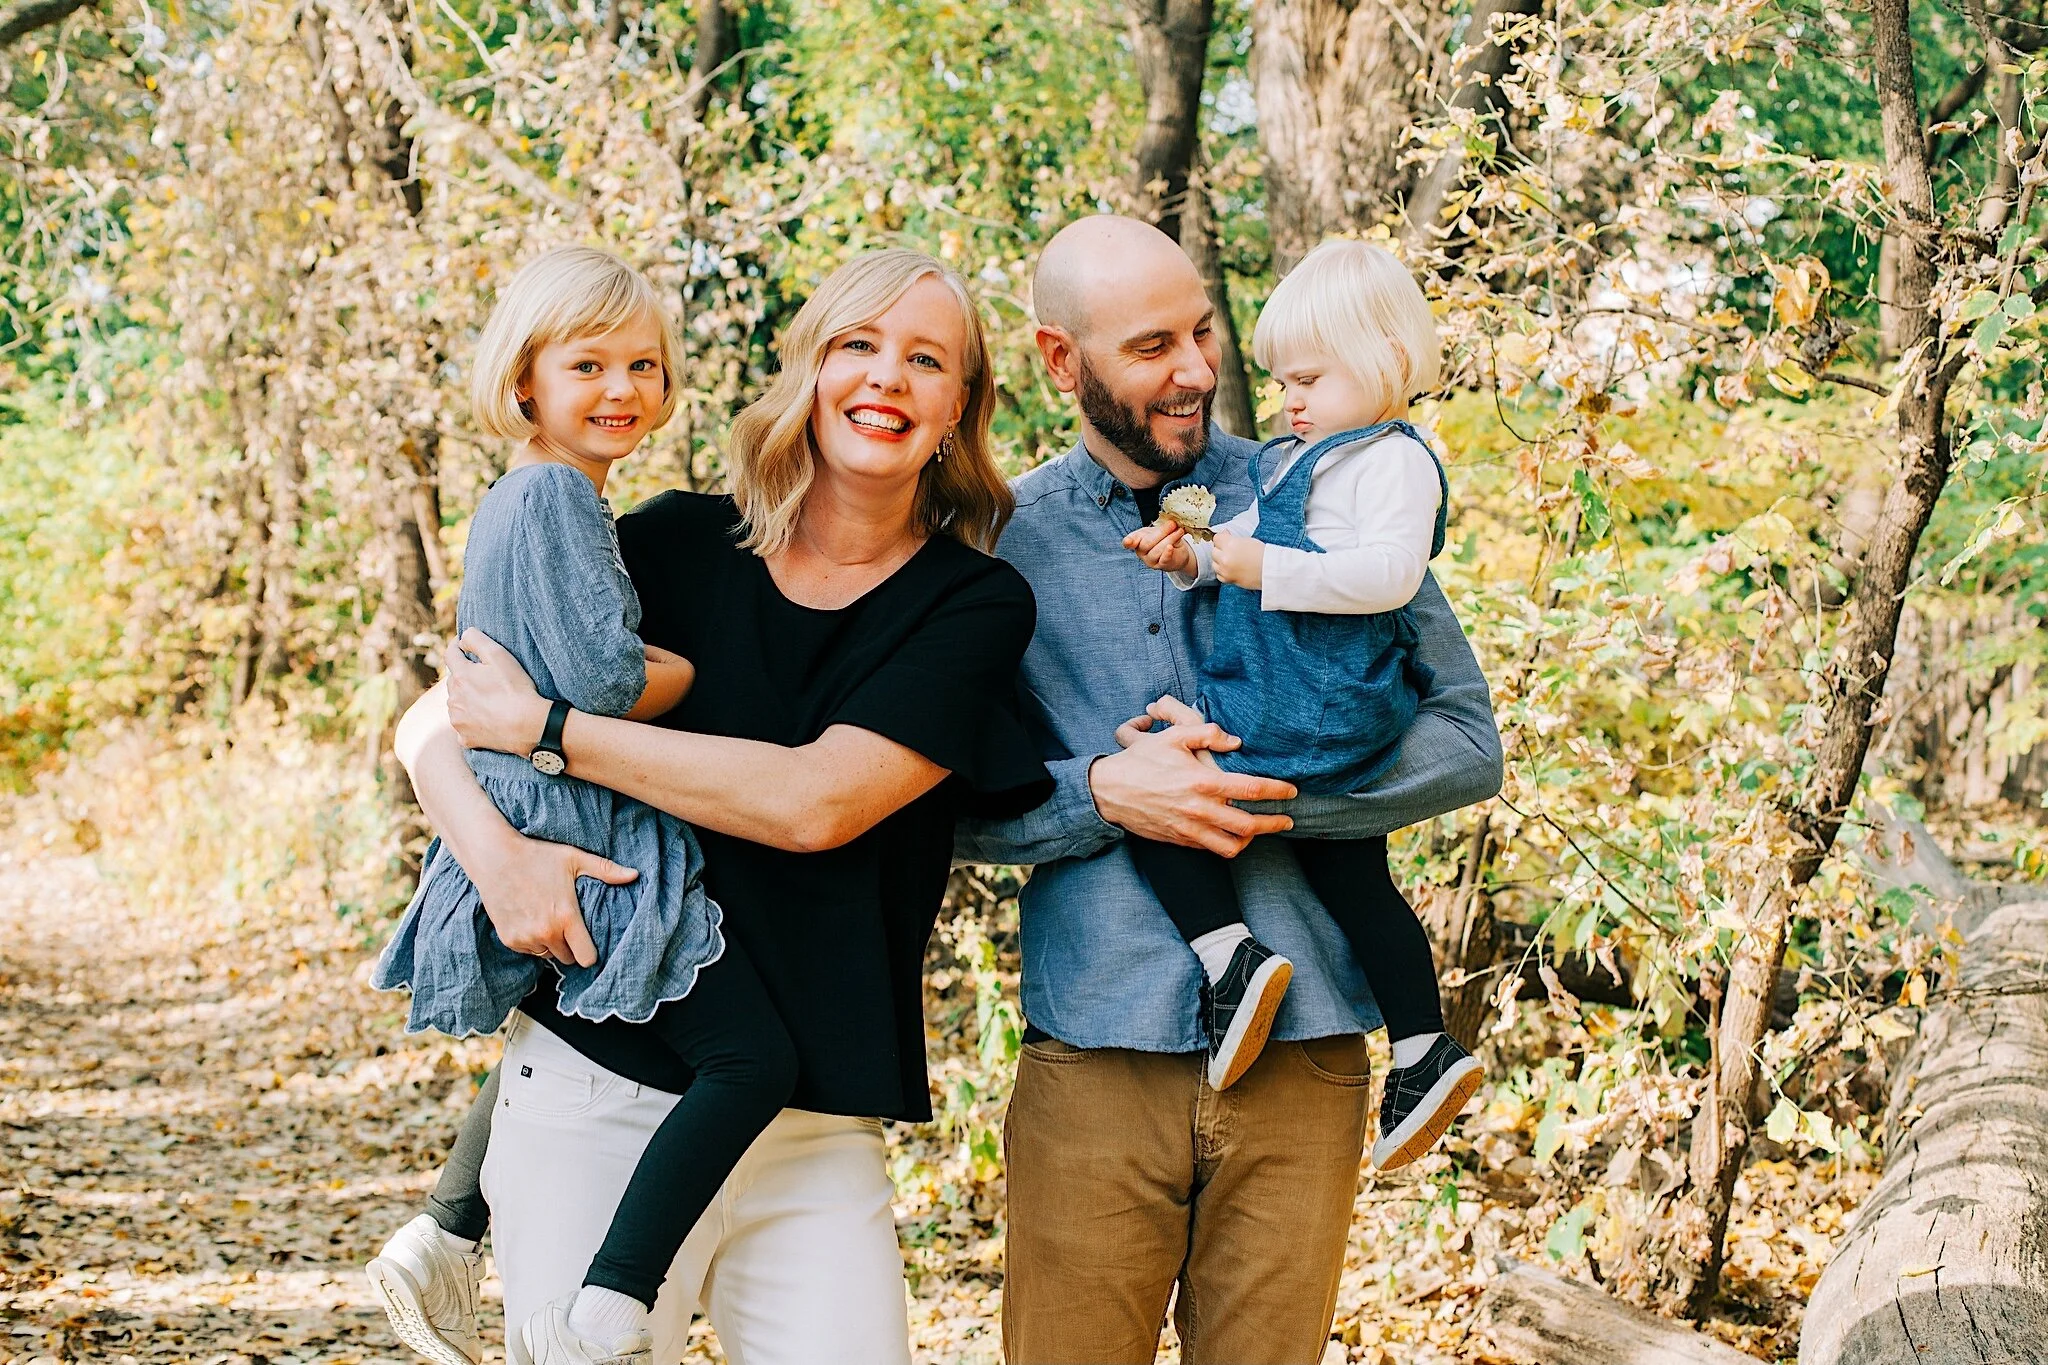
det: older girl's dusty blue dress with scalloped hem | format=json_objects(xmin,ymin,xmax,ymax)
[{"xmin": 371, "ymin": 465, "xmax": 725, "ymax": 1038}]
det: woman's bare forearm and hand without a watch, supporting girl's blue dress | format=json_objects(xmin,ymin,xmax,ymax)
[{"xmin": 393, "ymin": 679, "xmax": 639, "ymax": 966}]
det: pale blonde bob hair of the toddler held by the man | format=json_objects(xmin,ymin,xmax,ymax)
[{"xmin": 1251, "ymin": 237, "xmax": 1444, "ymax": 422}]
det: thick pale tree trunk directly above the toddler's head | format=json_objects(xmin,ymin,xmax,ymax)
[{"xmin": 1251, "ymin": 0, "xmax": 1448, "ymax": 274}]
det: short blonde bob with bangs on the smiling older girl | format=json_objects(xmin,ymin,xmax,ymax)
[{"xmin": 469, "ymin": 246, "xmax": 676, "ymax": 440}]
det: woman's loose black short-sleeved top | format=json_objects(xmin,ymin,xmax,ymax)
[{"xmin": 522, "ymin": 493, "xmax": 1053, "ymax": 1121}]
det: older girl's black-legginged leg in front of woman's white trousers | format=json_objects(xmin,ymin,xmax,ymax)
[{"xmin": 584, "ymin": 937, "xmax": 797, "ymax": 1308}]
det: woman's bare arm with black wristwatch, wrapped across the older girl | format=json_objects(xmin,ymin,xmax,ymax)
[{"xmin": 449, "ymin": 630, "xmax": 946, "ymax": 866}]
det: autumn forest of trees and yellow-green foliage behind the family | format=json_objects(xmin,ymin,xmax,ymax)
[{"xmin": 0, "ymin": 0, "xmax": 2048, "ymax": 1361}]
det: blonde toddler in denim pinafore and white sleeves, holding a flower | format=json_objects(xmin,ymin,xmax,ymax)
[{"xmin": 1124, "ymin": 239, "xmax": 1481, "ymax": 1169}]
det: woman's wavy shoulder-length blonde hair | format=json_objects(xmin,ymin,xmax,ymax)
[{"xmin": 725, "ymin": 248, "xmax": 1016, "ymax": 559}]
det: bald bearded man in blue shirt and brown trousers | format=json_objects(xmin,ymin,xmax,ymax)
[{"xmin": 954, "ymin": 217, "xmax": 1501, "ymax": 1365}]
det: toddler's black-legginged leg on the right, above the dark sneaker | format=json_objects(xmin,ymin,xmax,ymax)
[{"xmin": 1292, "ymin": 835, "xmax": 1444, "ymax": 1039}]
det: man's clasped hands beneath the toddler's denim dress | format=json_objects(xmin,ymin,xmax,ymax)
[{"xmin": 1087, "ymin": 716, "xmax": 1294, "ymax": 857}]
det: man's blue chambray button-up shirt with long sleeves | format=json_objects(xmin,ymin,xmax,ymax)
[{"xmin": 954, "ymin": 430, "xmax": 1501, "ymax": 1052}]
